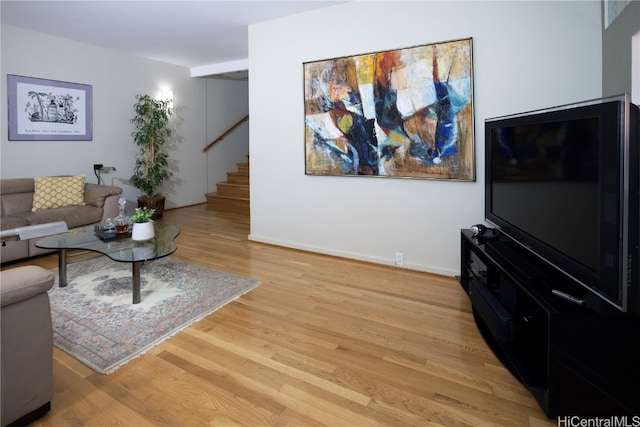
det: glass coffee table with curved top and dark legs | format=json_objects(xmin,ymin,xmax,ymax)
[{"xmin": 36, "ymin": 221, "xmax": 180, "ymax": 304}]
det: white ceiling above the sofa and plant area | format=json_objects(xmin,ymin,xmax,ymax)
[{"xmin": 0, "ymin": 0, "xmax": 344, "ymax": 78}]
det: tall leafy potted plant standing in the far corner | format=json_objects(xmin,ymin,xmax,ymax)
[{"xmin": 129, "ymin": 94, "xmax": 172, "ymax": 219}]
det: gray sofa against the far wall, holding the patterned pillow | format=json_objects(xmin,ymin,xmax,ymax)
[{"xmin": 0, "ymin": 178, "xmax": 122, "ymax": 263}]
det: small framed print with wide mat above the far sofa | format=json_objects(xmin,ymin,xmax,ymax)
[{"xmin": 7, "ymin": 74, "xmax": 93, "ymax": 141}]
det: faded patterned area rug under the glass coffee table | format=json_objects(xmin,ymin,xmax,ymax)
[{"xmin": 49, "ymin": 257, "xmax": 260, "ymax": 374}]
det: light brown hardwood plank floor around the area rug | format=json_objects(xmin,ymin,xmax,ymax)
[{"xmin": 3, "ymin": 205, "xmax": 556, "ymax": 426}]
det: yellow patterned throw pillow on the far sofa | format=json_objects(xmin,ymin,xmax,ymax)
[{"xmin": 31, "ymin": 175, "xmax": 85, "ymax": 212}]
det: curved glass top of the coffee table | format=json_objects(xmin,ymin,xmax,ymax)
[{"xmin": 36, "ymin": 221, "xmax": 180, "ymax": 263}]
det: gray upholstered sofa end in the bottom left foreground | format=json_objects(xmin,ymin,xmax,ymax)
[{"xmin": 0, "ymin": 265, "xmax": 54, "ymax": 427}]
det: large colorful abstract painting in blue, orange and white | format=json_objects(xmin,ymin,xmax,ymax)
[{"xmin": 303, "ymin": 38, "xmax": 475, "ymax": 181}]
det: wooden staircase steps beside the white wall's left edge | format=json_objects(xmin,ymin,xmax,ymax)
[{"xmin": 206, "ymin": 160, "xmax": 249, "ymax": 215}]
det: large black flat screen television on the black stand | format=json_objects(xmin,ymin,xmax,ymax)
[{"xmin": 485, "ymin": 95, "xmax": 640, "ymax": 312}]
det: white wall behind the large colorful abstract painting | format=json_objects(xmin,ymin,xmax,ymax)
[{"xmin": 249, "ymin": 1, "xmax": 602, "ymax": 275}]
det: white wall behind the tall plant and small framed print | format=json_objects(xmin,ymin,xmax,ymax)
[{"xmin": 0, "ymin": 25, "xmax": 208, "ymax": 208}]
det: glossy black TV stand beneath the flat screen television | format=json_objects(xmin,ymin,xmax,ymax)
[{"xmin": 459, "ymin": 230, "xmax": 640, "ymax": 418}]
